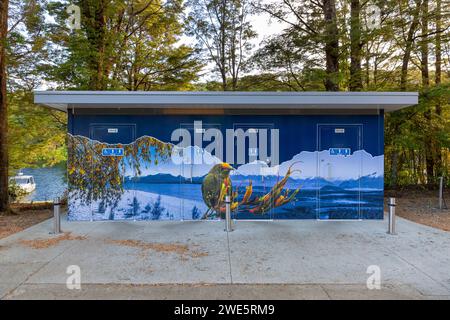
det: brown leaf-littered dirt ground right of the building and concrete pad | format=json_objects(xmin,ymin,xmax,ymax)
[{"xmin": 385, "ymin": 190, "xmax": 450, "ymax": 231}]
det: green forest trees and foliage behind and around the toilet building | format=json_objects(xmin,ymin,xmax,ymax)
[{"xmin": 6, "ymin": 0, "xmax": 450, "ymax": 188}]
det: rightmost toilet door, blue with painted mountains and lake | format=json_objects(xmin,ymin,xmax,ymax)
[{"xmin": 317, "ymin": 124, "xmax": 362, "ymax": 220}]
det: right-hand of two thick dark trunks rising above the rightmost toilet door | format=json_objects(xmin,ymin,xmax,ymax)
[{"xmin": 349, "ymin": 0, "xmax": 362, "ymax": 91}]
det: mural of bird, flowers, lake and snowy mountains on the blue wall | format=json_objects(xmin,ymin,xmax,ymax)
[{"xmin": 68, "ymin": 129, "xmax": 383, "ymax": 220}]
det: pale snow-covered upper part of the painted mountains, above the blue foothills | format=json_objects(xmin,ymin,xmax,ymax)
[{"xmin": 134, "ymin": 146, "xmax": 384, "ymax": 181}]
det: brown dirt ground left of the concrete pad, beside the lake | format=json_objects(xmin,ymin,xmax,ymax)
[{"xmin": 0, "ymin": 204, "xmax": 53, "ymax": 239}]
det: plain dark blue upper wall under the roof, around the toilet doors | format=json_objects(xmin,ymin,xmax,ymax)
[{"xmin": 69, "ymin": 113, "xmax": 384, "ymax": 159}]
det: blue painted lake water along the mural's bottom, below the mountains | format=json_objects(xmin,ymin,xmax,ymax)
[{"xmin": 126, "ymin": 183, "xmax": 383, "ymax": 219}]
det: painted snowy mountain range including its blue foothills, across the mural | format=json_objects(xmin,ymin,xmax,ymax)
[{"xmin": 126, "ymin": 146, "xmax": 384, "ymax": 190}]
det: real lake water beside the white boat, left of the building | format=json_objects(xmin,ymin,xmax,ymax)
[{"xmin": 22, "ymin": 166, "xmax": 67, "ymax": 201}]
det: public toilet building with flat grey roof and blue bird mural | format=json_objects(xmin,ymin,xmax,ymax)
[{"xmin": 35, "ymin": 91, "xmax": 418, "ymax": 220}]
